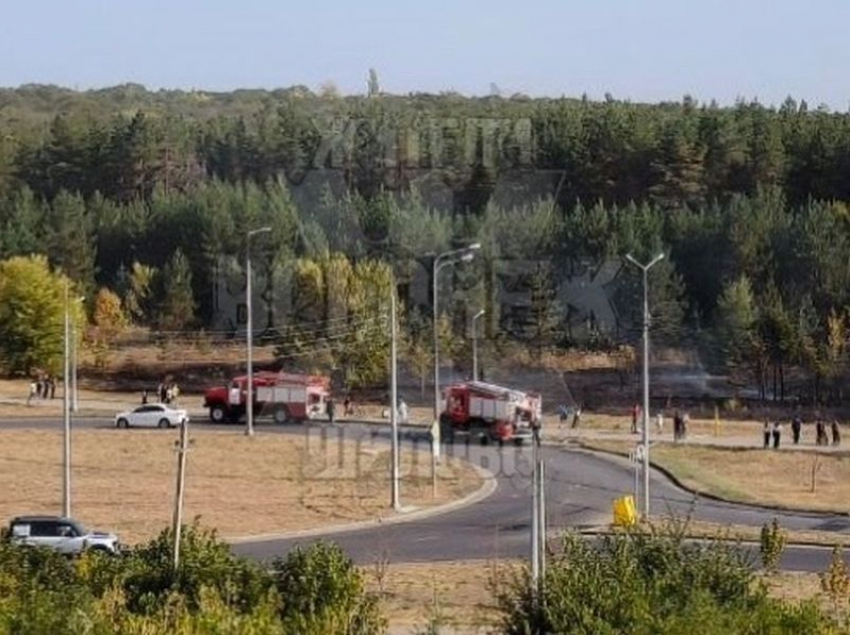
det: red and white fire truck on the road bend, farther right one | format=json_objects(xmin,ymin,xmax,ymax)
[{"xmin": 440, "ymin": 381, "xmax": 542, "ymax": 445}]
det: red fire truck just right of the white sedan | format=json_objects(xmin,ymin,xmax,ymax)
[{"xmin": 204, "ymin": 372, "xmax": 330, "ymax": 423}]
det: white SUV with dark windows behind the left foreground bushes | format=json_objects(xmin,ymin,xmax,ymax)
[{"xmin": 9, "ymin": 516, "xmax": 119, "ymax": 556}]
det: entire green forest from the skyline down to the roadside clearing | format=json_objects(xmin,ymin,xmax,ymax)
[{"xmin": 0, "ymin": 86, "xmax": 850, "ymax": 401}]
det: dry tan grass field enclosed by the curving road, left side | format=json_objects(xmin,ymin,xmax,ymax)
[{"xmin": 0, "ymin": 423, "xmax": 481, "ymax": 543}]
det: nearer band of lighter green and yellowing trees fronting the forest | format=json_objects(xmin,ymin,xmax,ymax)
[{"xmin": 6, "ymin": 181, "xmax": 850, "ymax": 400}]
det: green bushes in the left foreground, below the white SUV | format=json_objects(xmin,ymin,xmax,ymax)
[{"xmin": 0, "ymin": 525, "xmax": 386, "ymax": 635}]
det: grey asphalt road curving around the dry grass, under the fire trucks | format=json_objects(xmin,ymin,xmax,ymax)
[{"xmin": 0, "ymin": 419, "xmax": 850, "ymax": 571}]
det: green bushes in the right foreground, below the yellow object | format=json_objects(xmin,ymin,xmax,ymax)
[{"xmin": 499, "ymin": 533, "xmax": 838, "ymax": 635}]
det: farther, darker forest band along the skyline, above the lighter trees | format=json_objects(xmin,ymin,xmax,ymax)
[{"xmin": 0, "ymin": 85, "xmax": 850, "ymax": 206}]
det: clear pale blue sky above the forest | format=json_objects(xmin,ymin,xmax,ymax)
[{"xmin": 0, "ymin": 0, "xmax": 850, "ymax": 111}]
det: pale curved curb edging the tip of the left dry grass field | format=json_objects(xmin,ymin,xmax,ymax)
[{"xmin": 229, "ymin": 463, "xmax": 499, "ymax": 545}]
